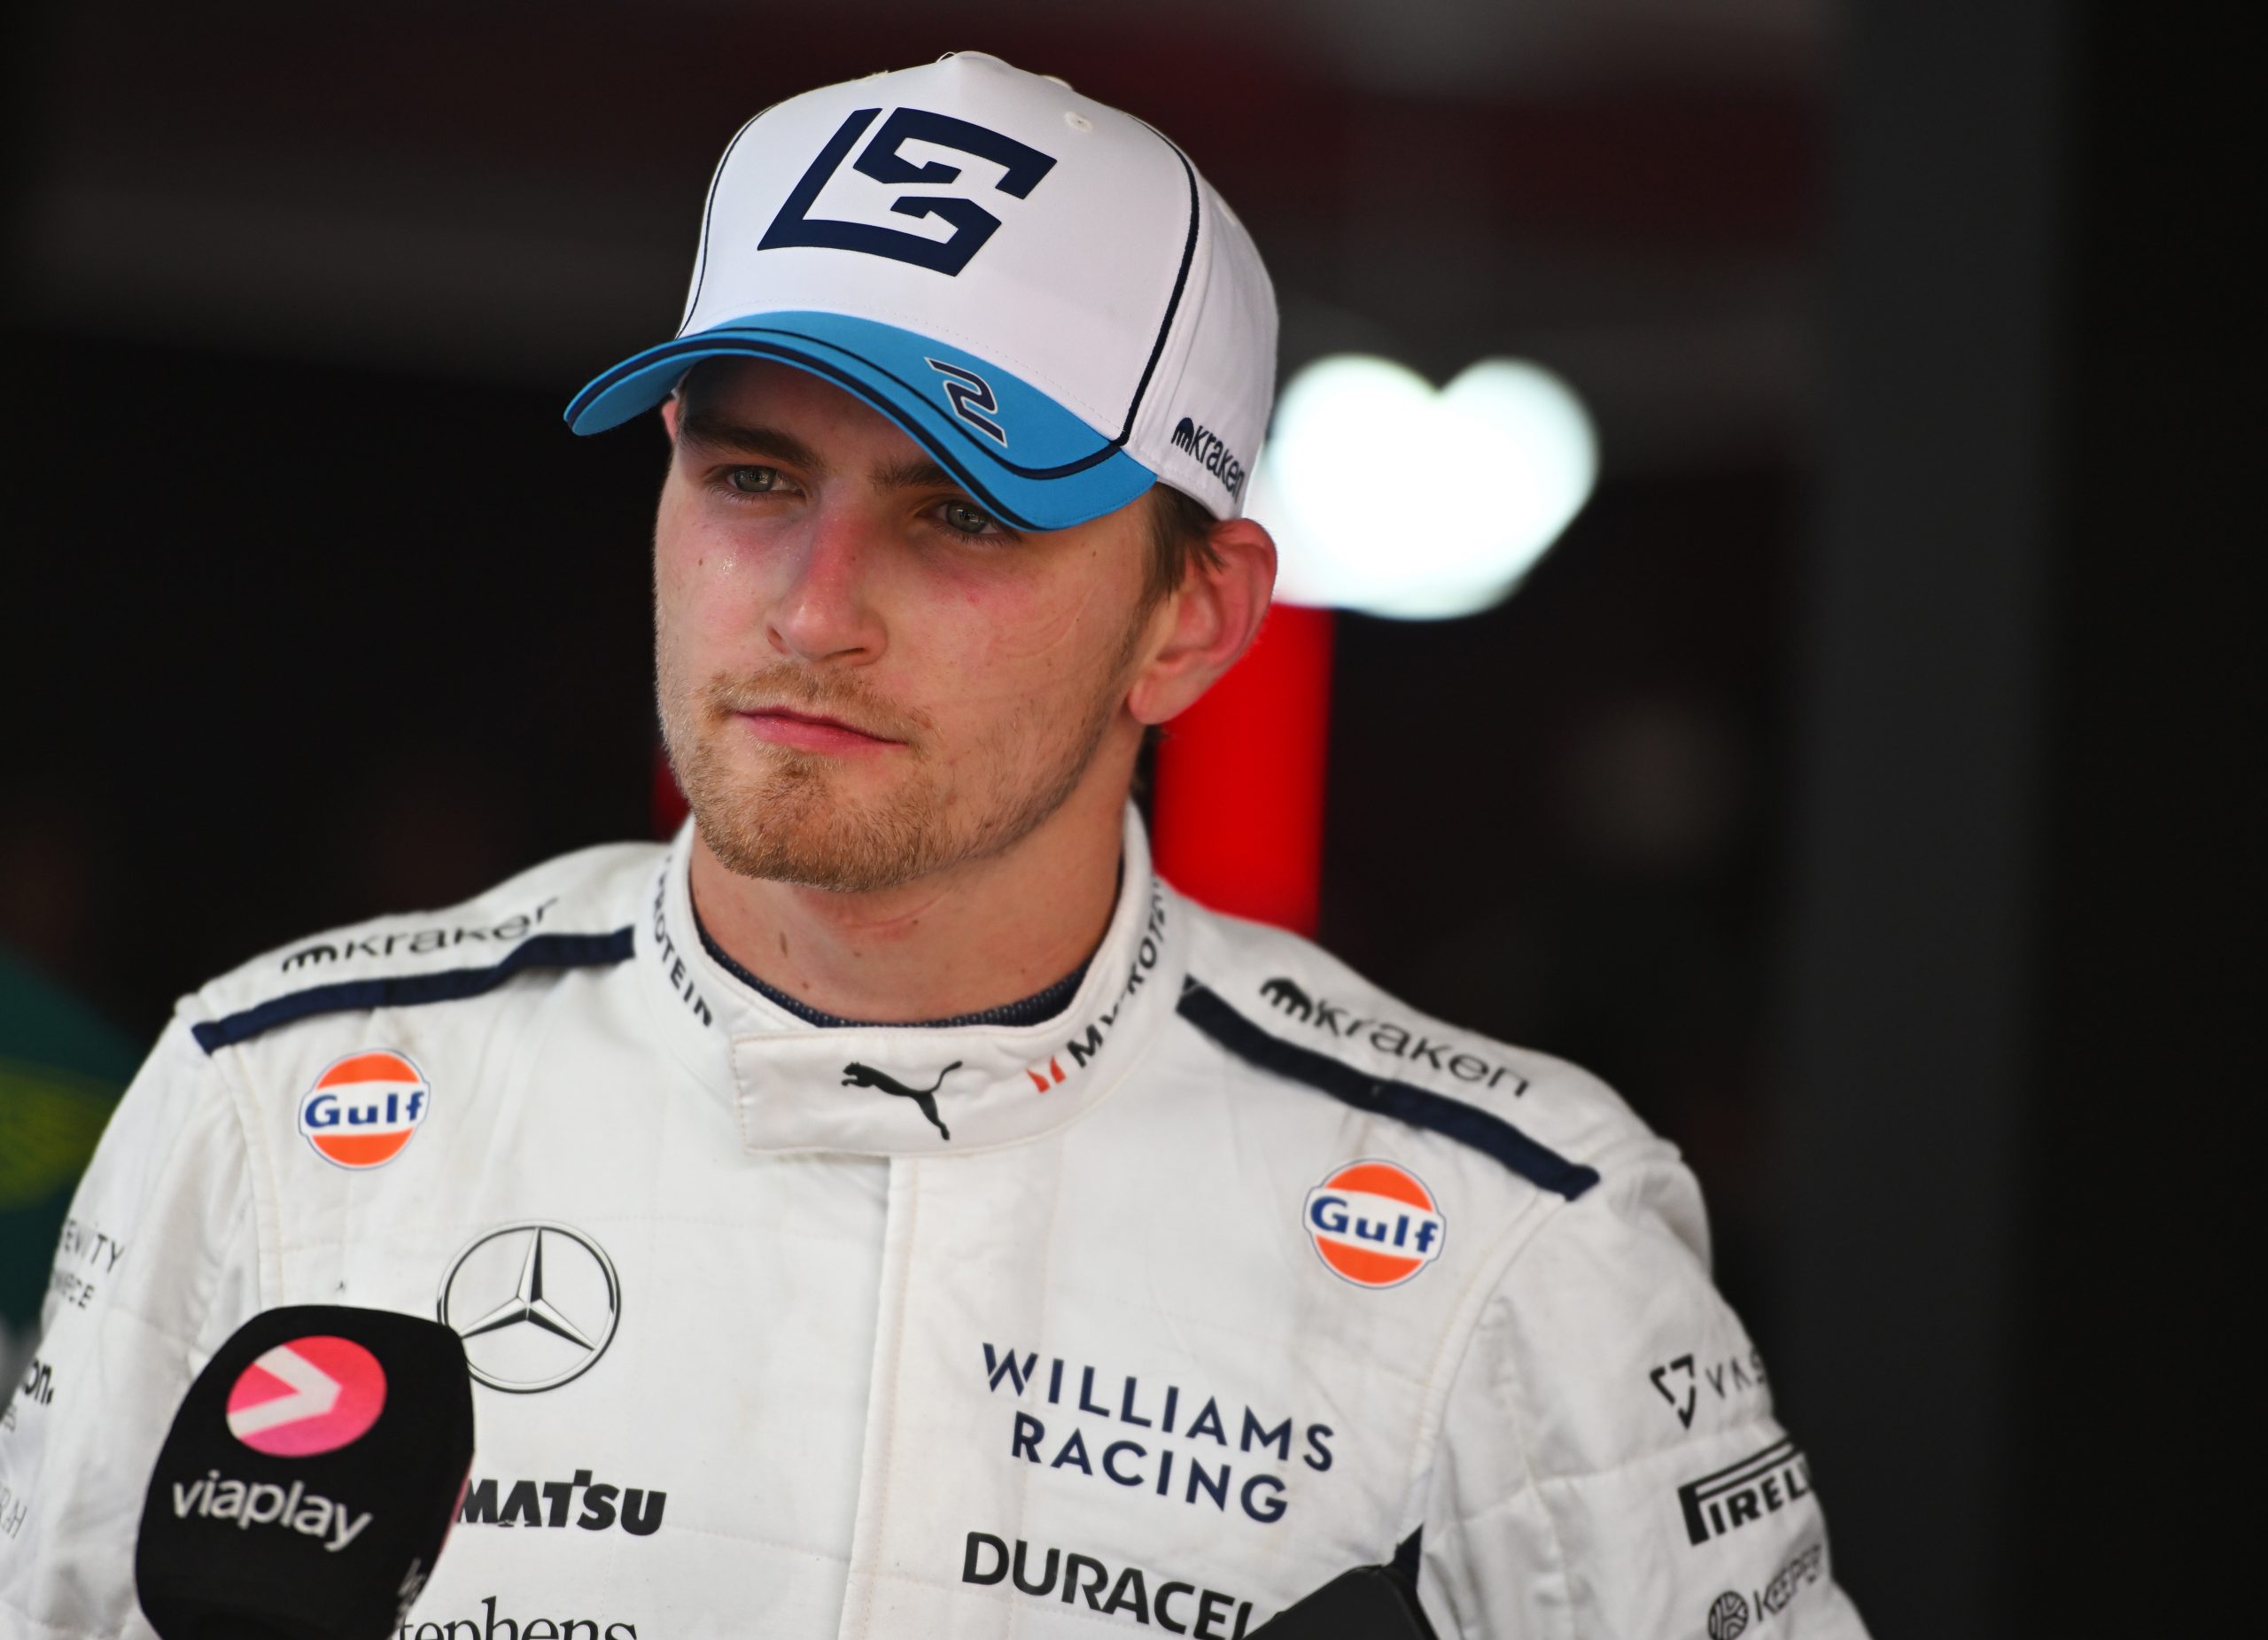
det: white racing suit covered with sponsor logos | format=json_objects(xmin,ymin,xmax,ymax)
[{"xmin": 0, "ymin": 817, "xmax": 1862, "ymax": 1640}]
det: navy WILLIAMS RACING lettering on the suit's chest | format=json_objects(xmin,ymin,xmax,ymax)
[{"xmin": 984, "ymin": 1343, "xmax": 1336, "ymax": 1527}]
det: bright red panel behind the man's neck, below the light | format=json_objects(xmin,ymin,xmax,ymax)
[{"xmin": 1150, "ymin": 603, "xmax": 1332, "ymax": 935}]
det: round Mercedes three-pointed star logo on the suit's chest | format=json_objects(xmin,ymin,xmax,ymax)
[{"xmin": 438, "ymin": 1220, "xmax": 621, "ymax": 1395}]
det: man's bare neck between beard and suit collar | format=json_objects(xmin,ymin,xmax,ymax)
[{"xmin": 692, "ymin": 782, "xmax": 1125, "ymax": 1023}]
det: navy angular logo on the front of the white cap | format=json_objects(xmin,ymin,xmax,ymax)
[{"xmin": 757, "ymin": 109, "xmax": 1054, "ymax": 275}]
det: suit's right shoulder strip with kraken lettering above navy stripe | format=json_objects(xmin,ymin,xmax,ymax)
[{"xmin": 1182, "ymin": 907, "xmax": 1676, "ymax": 1200}]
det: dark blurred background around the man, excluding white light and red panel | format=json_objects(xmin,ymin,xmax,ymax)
[{"xmin": 0, "ymin": 0, "xmax": 2261, "ymax": 1636}]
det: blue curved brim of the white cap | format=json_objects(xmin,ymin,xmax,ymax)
[{"xmin": 567, "ymin": 313, "xmax": 1157, "ymax": 529}]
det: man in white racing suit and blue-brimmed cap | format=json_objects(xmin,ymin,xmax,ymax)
[{"xmin": 0, "ymin": 54, "xmax": 1860, "ymax": 1640}]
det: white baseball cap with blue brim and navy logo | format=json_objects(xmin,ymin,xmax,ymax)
[{"xmin": 567, "ymin": 52, "xmax": 1277, "ymax": 529}]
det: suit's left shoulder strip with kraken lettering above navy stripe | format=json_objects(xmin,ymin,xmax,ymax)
[{"xmin": 182, "ymin": 843, "xmax": 667, "ymax": 1053}]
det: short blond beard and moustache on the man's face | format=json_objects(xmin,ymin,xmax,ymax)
[{"xmin": 656, "ymin": 619, "xmax": 1141, "ymax": 894}]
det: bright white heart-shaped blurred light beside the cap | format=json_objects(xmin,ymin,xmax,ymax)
[{"xmin": 1250, "ymin": 354, "xmax": 1599, "ymax": 619}]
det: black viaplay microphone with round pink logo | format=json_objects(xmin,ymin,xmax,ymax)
[{"xmin": 134, "ymin": 1304, "xmax": 471, "ymax": 1640}]
